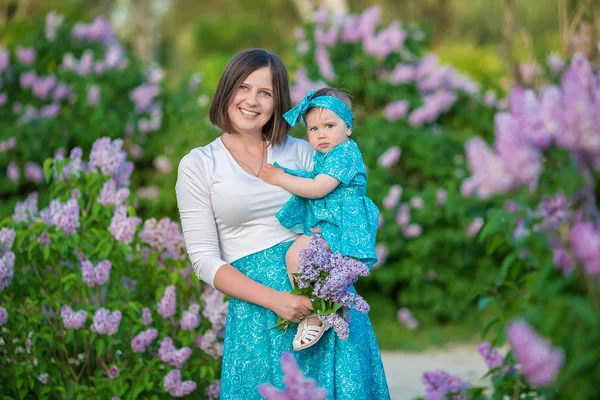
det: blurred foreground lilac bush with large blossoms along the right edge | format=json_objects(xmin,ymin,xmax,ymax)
[{"xmin": 448, "ymin": 54, "xmax": 600, "ymax": 399}]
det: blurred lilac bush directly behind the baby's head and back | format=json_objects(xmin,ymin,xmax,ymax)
[{"xmin": 292, "ymin": 6, "xmax": 504, "ymax": 322}]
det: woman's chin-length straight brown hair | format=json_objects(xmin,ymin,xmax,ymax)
[{"xmin": 210, "ymin": 49, "xmax": 292, "ymax": 145}]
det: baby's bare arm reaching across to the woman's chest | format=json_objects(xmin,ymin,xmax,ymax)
[{"xmin": 258, "ymin": 164, "xmax": 340, "ymax": 199}]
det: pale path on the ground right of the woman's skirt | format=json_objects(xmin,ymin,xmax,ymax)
[{"xmin": 382, "ymin": 344, "xmax": 487, "ymax": 400}]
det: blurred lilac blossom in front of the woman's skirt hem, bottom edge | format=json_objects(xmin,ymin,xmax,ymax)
[{"xmin": 258, "ymin": 353, "xmax": 328, "ymax": 400}]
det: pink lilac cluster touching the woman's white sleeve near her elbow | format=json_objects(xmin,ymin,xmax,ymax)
[{"xmin": 138, "ymin": 217, "xmax": 185, "ymax": 255}]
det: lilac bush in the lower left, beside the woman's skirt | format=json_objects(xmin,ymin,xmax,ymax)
[{"xmin": 0, "ymin": 138, "xmax": 228, "ymax": 399}]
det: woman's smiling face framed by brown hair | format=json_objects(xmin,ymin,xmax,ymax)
[{"xmin": 227, "ymin": 67, "xmax": 275, "ymax": 133}]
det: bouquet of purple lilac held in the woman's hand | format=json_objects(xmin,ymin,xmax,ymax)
[{"xmin": 277, "ymin": 235, "xmax": 370, "ymax": 340}]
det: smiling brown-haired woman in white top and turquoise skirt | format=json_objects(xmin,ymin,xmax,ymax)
[{"xmin": 176, "ymin": 49, "xmax": 389, "ymax": 400}]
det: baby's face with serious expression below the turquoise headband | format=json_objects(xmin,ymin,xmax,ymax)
[{"xmin": 306, "ymin": 108, "xmax": 352, "ymax": 153}]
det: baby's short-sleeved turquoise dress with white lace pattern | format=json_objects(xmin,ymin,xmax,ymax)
[{"xmin": 275, "ymin": 140, "xmax": 379, "ymax": 266}]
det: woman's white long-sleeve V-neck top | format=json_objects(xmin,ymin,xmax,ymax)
[{"xmin": 175, "ymin": 136, "xmax": 314, "ymax": 287}]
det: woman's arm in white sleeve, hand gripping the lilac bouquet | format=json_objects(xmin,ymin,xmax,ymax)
[{"xmin": 175, "ymin": 154, "xmax": 312, "ymax": 321}]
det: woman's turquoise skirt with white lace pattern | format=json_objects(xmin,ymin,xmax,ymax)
[{"xmin": 221, "ymin": 242, "xmax": 390, "ymax": 400}]
